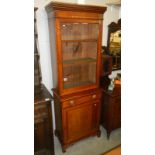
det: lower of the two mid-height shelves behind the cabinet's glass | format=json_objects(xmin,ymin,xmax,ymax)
[{"xmin": 63, "ymin": 58, "xmax": 96, "ymax": 65}]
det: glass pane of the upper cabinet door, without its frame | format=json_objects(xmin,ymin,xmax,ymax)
[{"xmin": 61, "ymin": 22, "xmax": 99, "ymax": 89}]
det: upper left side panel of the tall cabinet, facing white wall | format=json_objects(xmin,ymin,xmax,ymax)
[{"xmin": 48, "ymin": 17, "xmax": 58, "ymax": 88}]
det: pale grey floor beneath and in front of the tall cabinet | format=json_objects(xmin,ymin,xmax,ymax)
[{"xmin": 54, "ymin": 127, "xmax": 121, "ymax": 155}]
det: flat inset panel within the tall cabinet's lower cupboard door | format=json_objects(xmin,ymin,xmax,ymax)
[{"xmin": 66, "ymin": 104, "xmax": 93, "ymax": 140}]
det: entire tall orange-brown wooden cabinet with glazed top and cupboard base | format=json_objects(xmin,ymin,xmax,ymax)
[{"xmin": 46, "ymin": 2, "xmax": 106, "ymax": 151}]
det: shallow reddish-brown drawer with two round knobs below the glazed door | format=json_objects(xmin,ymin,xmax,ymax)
[{"xmin": 62, "ymin": 93, "xmax": 101, "ymax": 108}]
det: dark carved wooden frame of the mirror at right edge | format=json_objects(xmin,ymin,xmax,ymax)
[{"xmin": 107, "ymin": 19, "xmax": 121, "ymax": 70}]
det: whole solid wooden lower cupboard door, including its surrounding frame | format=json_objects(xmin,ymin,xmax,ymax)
[{"xmin": 63, "ymin": 103, "xmax": 98, "ymax": 142}]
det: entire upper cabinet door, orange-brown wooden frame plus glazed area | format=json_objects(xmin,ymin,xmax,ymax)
[{"xmin": 56, "ymin": 19, "xmax": 102, "ymax": 95}]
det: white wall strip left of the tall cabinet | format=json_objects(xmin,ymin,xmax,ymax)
[{"xmin": 35, "ymin": 0, "xmax": 53, "ymax": 92}]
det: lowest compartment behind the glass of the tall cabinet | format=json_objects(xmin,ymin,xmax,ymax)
[{"xmin": 63, "ymin": 62, "xmax": 96, "ymax": 89}]
